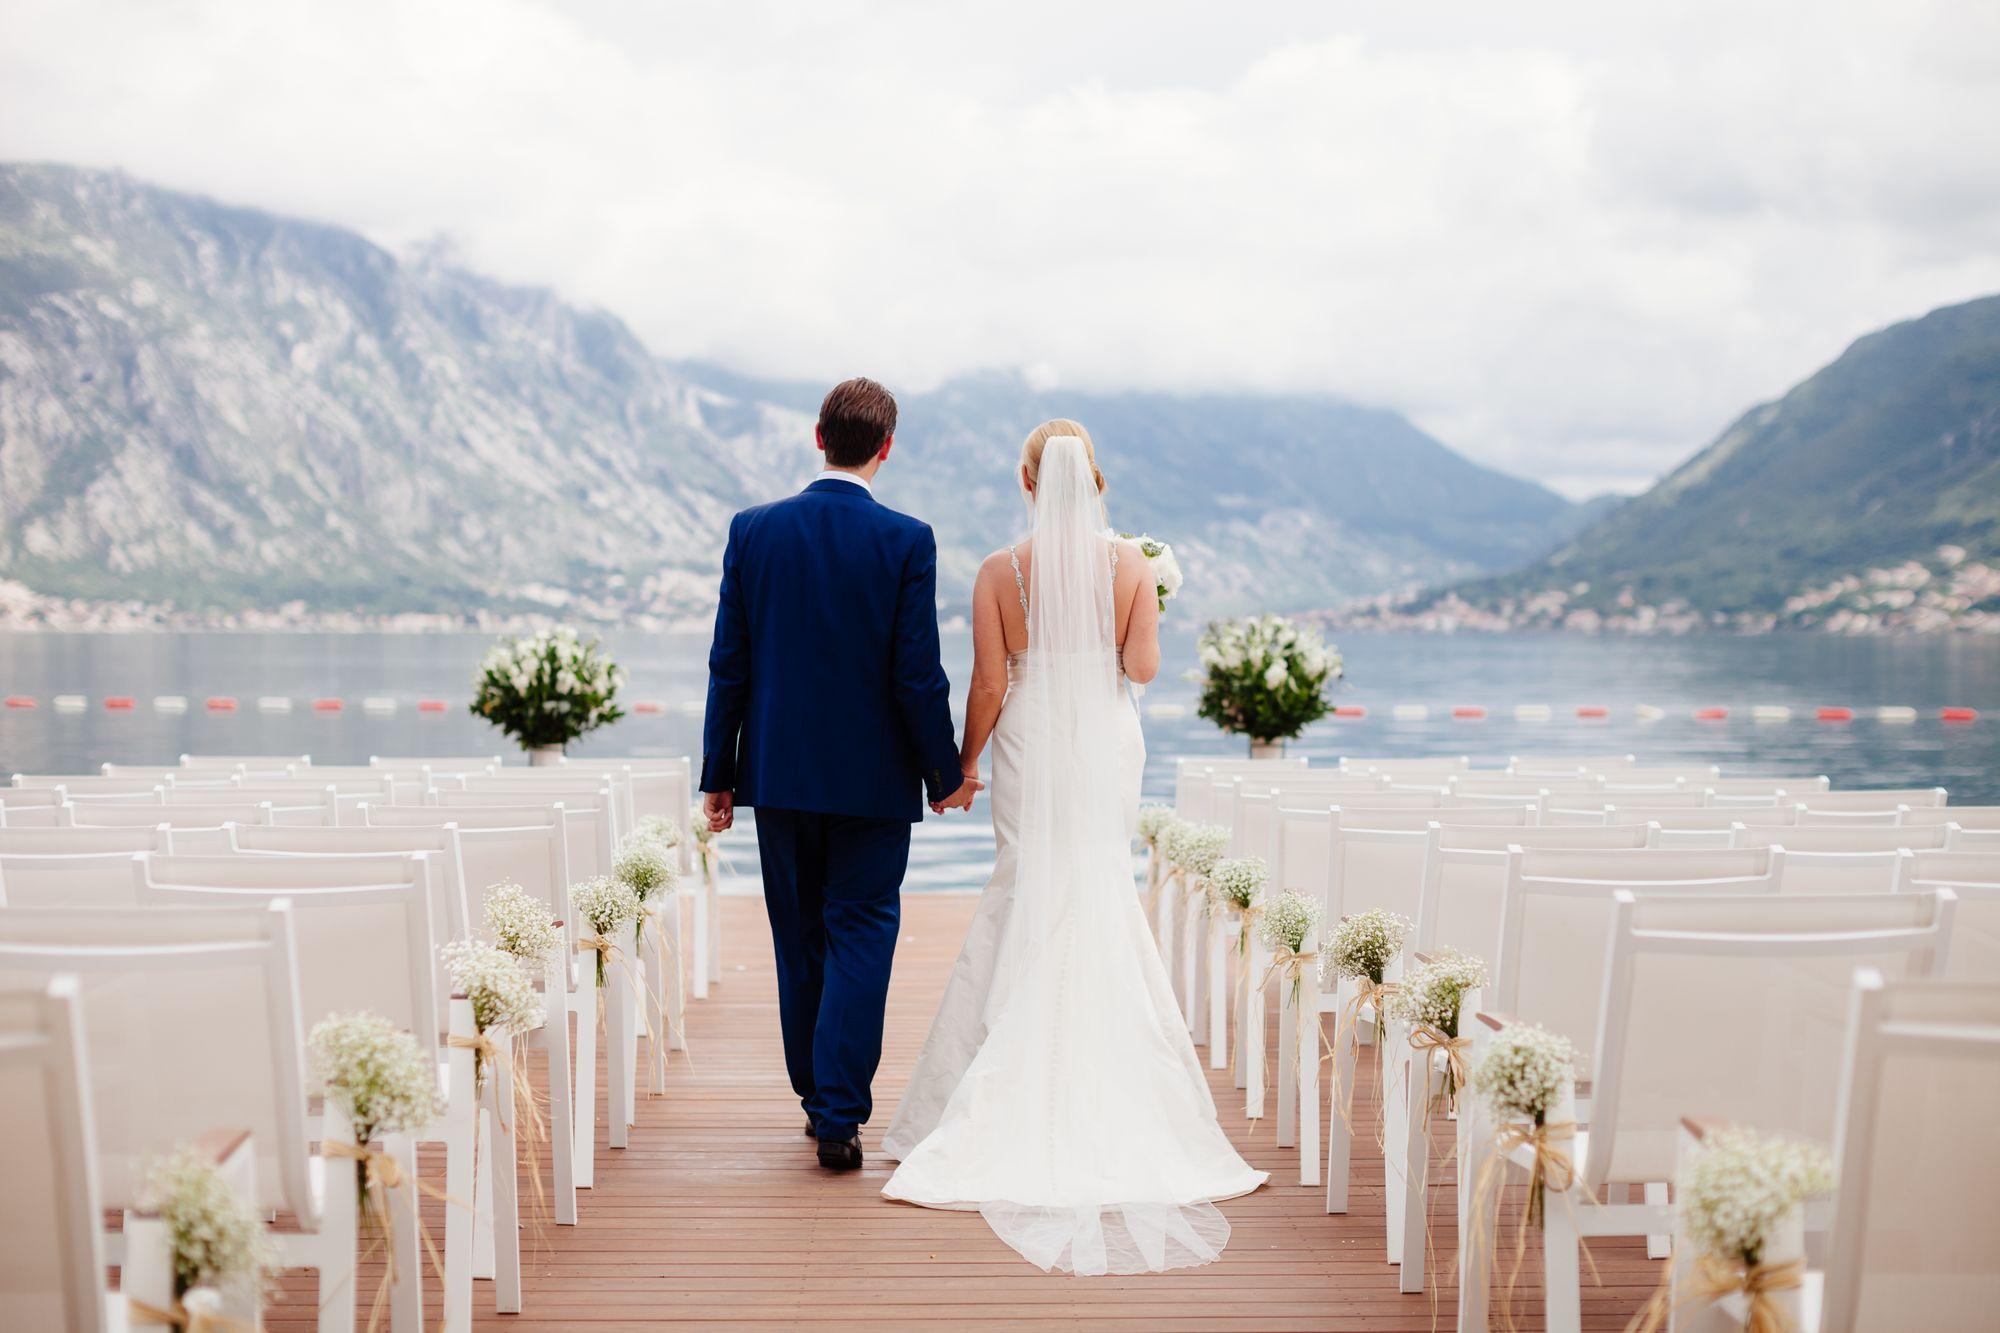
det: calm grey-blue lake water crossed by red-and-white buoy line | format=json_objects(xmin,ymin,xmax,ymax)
[{"xmin": 0, "ymin": 632, "xmax": 2000, "ymax": 889}]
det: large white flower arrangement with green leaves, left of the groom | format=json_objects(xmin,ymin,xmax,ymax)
[{"xmin": 472, "ymin": 626, "xmax": 624, "ymax": 751}]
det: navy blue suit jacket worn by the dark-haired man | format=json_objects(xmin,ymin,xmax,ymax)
[{"xmin": 702, "ymin": 478, "xmax": 964, "ymax": 823}]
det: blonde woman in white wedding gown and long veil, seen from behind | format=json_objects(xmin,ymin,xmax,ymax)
[{"xmin": 882, "ymin": 420, "xmax": 1266, "ymax": 1273}]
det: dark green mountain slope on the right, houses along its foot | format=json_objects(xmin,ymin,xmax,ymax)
[{"xmin": 1400, "ymin": 296, "xmax": 2000, "ymax": 628}]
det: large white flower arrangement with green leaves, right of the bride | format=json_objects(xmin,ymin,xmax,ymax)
[{"xmin": 1196, "ymin": 616, "xmax": 1342, "ymax": 745}]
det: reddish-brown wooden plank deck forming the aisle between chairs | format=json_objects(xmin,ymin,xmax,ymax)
[{"xmin": 268, "ymin": 895, "xmax": 1660, "ymax": 1331}]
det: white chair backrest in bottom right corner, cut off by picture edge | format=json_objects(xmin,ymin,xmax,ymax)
[{"xmin": 1820, "ymin": 969, "xmax": 2000, "ymax": 1329}]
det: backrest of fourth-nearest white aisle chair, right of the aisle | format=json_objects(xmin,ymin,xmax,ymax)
[{"xmin": 1410, "ymin": 815, "xmax": 1646, "ymax": 956}]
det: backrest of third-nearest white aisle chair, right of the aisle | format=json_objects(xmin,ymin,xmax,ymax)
[{"xmin": 1486, "ymin": 847, "xmax": 1784, "ymax": 1064}]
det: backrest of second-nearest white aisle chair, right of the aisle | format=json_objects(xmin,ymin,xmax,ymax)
[{"xmin": 1584, "ymin": 889, "xmax": 1952, "ymax": 1185}]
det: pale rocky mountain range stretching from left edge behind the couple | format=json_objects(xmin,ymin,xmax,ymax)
[{"xmin": 0, "ymin": 166, "xmax": 1576, "ymax": 618}]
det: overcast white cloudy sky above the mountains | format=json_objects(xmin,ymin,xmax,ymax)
[{"xmin": 0, "ymin": 0, "xmax": 2000, "ymax": 494}]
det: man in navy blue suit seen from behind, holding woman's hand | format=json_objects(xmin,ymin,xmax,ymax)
[{"xmin": 702, "ymin": 380, "xmax": 978, "ymax": 1171}]
